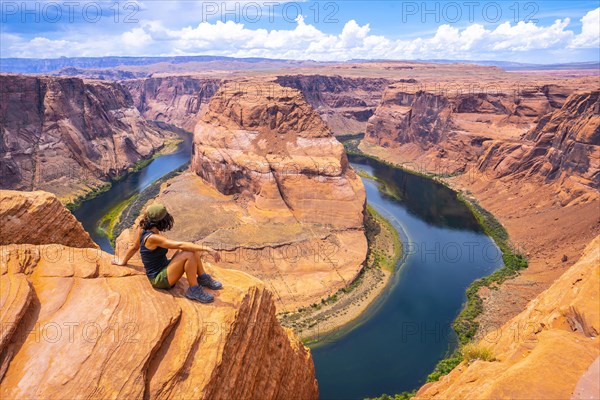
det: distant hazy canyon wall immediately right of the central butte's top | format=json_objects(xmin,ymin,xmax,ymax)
[{"xmin": 275, "ymin": 74, "xmax": 391, "ymax": 135}]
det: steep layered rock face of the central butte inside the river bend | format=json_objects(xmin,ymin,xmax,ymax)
[{"xmin": 192, "ymin": 81, "xmax": 365, "ymax": 229}]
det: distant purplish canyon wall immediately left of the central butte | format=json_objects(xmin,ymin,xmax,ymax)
[{"xmin": 122, "ymin": 75, "xmax": 221, "ymax": 132}]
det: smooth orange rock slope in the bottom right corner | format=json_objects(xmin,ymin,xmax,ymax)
[{"xmin": 416, "ymin": 237, "xmax": 600, "ymax": 399}]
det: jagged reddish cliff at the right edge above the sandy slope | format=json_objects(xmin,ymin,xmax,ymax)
[{"xmin": 478, "ymin": 91, "xmax": 600, "ymax": 203}]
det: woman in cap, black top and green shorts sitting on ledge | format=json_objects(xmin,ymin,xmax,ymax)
[{"xmin": 113, "ymin": 203, "xmax": 223, "ymax": 303}]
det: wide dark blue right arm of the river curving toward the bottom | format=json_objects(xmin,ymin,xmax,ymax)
[{"xmin": 312, "ymin": 157, "xmax": 502, "ymax": 399}]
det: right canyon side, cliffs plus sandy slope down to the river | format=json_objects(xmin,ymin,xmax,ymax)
[{"xmin": 360, "ymin": 78, "xmax": 600, "ymax": 329}]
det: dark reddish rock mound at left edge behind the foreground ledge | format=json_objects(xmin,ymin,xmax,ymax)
[{"xmin": 0, "ymin": 190, "xmax": 97, "ymax": 248}]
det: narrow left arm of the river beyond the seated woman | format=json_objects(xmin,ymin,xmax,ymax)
[{"xmin": 73, "ymin": 134, "xmax": 192, "ymax": 253}]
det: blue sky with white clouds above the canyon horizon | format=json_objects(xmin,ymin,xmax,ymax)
[{"xmin": 0, "ymin": 0, "xmax": 600, "ymax": 64}]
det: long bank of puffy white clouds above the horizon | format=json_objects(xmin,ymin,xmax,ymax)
[{"xmin": 1, "ymin": 8, "xmax": 600, "ymax": 61}]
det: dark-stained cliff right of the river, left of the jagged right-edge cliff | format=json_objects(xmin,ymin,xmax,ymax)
[{"xmin": 365, "ymin": 83, "xmax": 571, "ymax": 174}]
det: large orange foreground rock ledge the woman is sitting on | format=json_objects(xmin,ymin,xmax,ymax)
[{"xmin": 0, "ymin": 192, "xmax": 318, "ymax": 399}]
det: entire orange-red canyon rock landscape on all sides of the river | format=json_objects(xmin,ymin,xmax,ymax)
[{"xmin": 0, "ymin": 62, "xmax": 600, "ymax": 398}]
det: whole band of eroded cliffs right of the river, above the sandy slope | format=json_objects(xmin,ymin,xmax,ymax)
[{"xmin": 364, "ymin": 82, "xmax": 600, "ymax": 204}]
